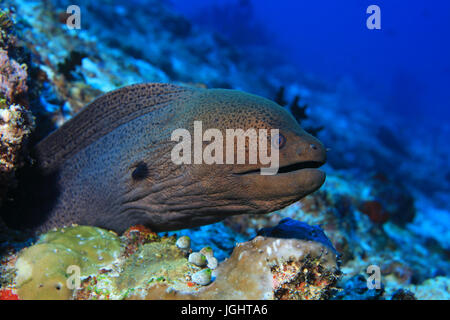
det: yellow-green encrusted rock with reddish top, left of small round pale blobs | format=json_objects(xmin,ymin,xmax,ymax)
[{"xmin": 0, "ymin": 226, "xmax": 214, "ymax": 299}]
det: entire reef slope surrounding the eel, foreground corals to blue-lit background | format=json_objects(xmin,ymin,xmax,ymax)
[{"xmin": 0, "ymin": 0, "xmax": 450, "ymax": 300}]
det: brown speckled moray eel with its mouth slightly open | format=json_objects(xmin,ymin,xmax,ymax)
[{"xmin": 4, "ymin": 83, "xmax": 326, "ymax": 233}]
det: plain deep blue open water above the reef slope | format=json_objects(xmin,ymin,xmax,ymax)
[{"xmin": 172, "ymin": 0, "xmax": 450, "ymax": 127}]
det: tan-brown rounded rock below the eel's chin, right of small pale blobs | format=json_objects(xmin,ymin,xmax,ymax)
[{"xmin": 139, "ymin": 220, "xmax": 340, "ymax": 300}]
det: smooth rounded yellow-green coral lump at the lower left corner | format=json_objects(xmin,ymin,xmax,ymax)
[{"xmin": 15, "ymin": 226, "xmax": 121, "ymax": 299}]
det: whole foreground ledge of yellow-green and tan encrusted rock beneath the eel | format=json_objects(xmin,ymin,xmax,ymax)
[{"xmin": 0, "ymin": 220, "xmax": 340, "ymax": 299}]
